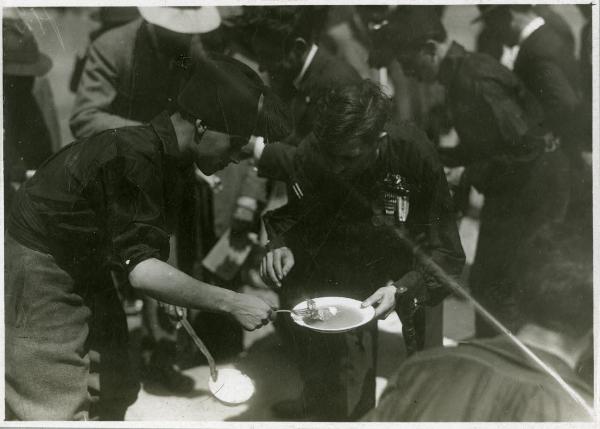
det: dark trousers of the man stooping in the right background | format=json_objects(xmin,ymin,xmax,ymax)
[{"xmin": 469, "ymin": 150, "xmax": 571, "ymax": 338}]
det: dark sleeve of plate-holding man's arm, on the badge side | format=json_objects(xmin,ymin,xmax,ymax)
[{"xmin": 394, "ymin": 127, "xmax": 465, "ymax": 304}]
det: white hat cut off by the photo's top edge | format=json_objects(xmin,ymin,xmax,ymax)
[{"xmin": 139, "ymin": 6, "xmax": 221, "ymax": 34}]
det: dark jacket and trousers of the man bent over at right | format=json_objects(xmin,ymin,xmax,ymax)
[{"xmin": 439, "ymin": 43, "xmax": 570, "ymax": 335}]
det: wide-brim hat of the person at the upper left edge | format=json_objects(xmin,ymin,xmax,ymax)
[{"xmin": 2, "ymin": 18, "xmax": 52, "ymax": 76}]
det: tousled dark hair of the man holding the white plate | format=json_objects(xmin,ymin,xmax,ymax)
[{"xmin": 314, "ymin": 79, "xmax": 391, "ymax": 148}]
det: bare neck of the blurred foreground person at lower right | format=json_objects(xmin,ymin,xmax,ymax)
[{"xmin": 517, "ymin": 324, "xmax": 589, "ymax": 369}]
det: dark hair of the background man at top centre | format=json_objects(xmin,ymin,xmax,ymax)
[{"xmin": 235, "ymin": 6, "xmax": 327, "ymax": 49}]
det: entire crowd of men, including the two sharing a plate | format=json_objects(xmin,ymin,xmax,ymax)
[{"xmin": 3, "ymin": 5, "xmax": 593, "ymax": 421}]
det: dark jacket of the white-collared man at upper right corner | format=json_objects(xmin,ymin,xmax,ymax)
[{"xmin": 513, "ymin": 24, "xmax": 580, "ymax": 154}]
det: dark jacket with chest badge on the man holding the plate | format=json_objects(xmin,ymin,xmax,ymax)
[{"xmin": 258, "ymin": 124, "xmax": 464, "ymax": 302}]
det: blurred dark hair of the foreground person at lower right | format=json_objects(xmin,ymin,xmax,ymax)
[{"xmin": 511, "ymin": 223, "xmax": 593, "ymax": 338}]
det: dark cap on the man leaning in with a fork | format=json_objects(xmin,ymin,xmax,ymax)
[{"xmin": 178, "ymin": 54, "xmax": 265, "ymax": 140}]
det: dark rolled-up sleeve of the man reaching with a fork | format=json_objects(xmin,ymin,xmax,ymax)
[{"xmin": 103, "ymin": 149, "xmax": 169, "ymax": 272}]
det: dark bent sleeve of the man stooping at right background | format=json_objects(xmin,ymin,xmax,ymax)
[{"xmin": 465, "ymin": 79, "xmax": 538, "ymax": 193}]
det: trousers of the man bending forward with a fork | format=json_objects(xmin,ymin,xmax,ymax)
[{"xmin": 4, "ymin": 234, "xmax": 139, "ymax": 420}]
